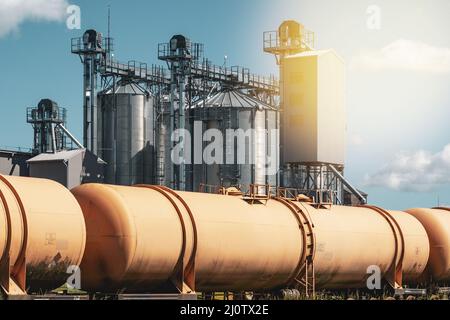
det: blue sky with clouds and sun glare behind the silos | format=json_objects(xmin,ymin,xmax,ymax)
[{"xmin": 0, "ymin": 0, "xmax": 450, "ymax": 209}]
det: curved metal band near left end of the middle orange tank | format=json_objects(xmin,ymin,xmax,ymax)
[{"xmin": 136, "ymin": 185, "xmax": 197, "ymax": 291}]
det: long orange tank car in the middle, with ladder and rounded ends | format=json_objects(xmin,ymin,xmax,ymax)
[{"xmin": 73, "ymin": 185, "xmax": 429, "ymax": 292}]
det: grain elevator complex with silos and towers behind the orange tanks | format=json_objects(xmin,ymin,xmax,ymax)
[{"xmin": 2, "ymin": 21, "xmax": 367, "ymax": 204}]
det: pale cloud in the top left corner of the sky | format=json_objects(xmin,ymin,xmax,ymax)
[{"xmin": 0, "ymin": 0, "xmax": 69, "ymax": 37}]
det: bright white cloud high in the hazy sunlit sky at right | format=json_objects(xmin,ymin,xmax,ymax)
[{"xmin": 351, "ymin": 39, "xmax": 450, "ymax": 73}]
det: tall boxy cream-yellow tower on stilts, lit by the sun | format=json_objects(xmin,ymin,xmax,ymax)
[{"xmin": 264, "ymin": 20, "xmax": 366, "ymax": 204}]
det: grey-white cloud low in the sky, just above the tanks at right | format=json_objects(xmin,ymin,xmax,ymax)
[{"xmin": 364, "ymin": 144, "xmax": 450, "ymax": 191}]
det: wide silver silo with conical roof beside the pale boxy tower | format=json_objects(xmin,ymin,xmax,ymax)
[{"xmin": 189, "ymin": 90, "xmax": 279, "ymax": 191}]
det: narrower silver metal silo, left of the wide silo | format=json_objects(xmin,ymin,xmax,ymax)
[{"xmin": 98, "ymin": 83, "xmax": 155, "ymax": 185}]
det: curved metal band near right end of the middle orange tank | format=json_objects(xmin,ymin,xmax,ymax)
[{"xmin": 358, "ymin": 205, "xmax": 405, "ymax": 286}]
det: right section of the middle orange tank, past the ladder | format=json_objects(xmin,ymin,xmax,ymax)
[{"xmin": 299, "ymin": 203, "xmax": 429, "ymax": 289}]
